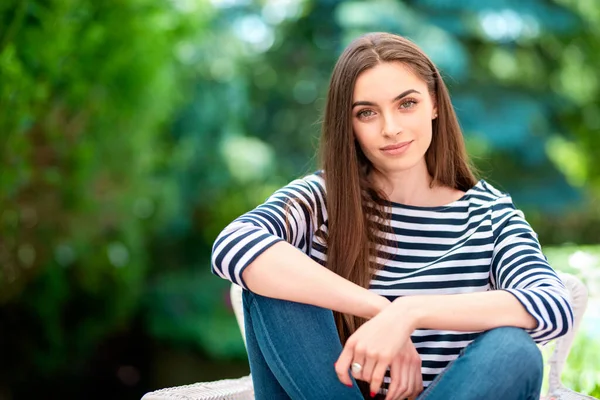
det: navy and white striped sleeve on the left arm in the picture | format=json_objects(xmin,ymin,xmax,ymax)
[{"xmin": 211, "ymin": 174, "xmax": 324, "ymax": 289}]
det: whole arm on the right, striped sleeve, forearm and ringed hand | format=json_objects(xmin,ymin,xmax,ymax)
[{"xmin": 336, "ymin": 197, "xmax": 573, "ymax": 392}]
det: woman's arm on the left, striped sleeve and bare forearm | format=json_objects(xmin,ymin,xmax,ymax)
[{"xmin": 211, "ymin": 175, "xmax": 390, "ymax": 318}]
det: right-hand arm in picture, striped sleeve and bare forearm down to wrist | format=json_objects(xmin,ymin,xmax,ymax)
[{"xmin": 394, "ymin": 196, "xmax": 573, "ymax": 343}]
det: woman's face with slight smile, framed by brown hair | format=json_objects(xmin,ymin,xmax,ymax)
[{"xmin": 352, "ymin": 62, "xmax": 437, "ymax": 175}]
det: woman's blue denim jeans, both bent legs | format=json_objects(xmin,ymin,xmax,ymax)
[{"xmin": 243, "ymin": 290, "xmax": 543, "ymax": 400}]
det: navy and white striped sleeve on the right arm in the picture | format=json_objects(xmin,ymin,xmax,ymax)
[{"xmin": 490, "ymin": 196, "xmax": 573, "ymax": 343}]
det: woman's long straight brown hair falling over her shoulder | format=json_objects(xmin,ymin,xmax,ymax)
[{"xmin": 320, "ymin": 33, "xmax": 477, "ymax": 343}]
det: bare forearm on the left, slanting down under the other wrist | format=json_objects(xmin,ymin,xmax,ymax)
[{"xmin": 242, "ymin": 242, "xmax": 390, "ymax": 318}]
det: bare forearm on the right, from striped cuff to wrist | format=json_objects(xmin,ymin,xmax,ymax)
[{"xmin": 393, "ymin": 290, "xmax": 537, "ymax": 331}]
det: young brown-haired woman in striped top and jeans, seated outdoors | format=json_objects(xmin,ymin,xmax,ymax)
[{"xmin": 212, "ymin": 33, "xmax": 573, "ymax": 400}]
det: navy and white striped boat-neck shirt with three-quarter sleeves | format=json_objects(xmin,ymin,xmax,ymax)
[{"xmin": 212, "ymin": 172, "xmax": 573, "ymax": 387}]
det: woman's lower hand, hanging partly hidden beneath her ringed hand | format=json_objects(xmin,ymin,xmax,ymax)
[{"xmin": 385, "ymin": 340, "xmax": 423, "ymax": 400}]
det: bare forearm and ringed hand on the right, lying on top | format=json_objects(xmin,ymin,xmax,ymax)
[{"xmin": 335, "ymin": 290, "xmax": 537, "ymax": 395}]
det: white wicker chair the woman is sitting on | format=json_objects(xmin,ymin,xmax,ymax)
[{"xmin": 142, "ymin": 274, "xmax": 594, "ymax": 400}]
